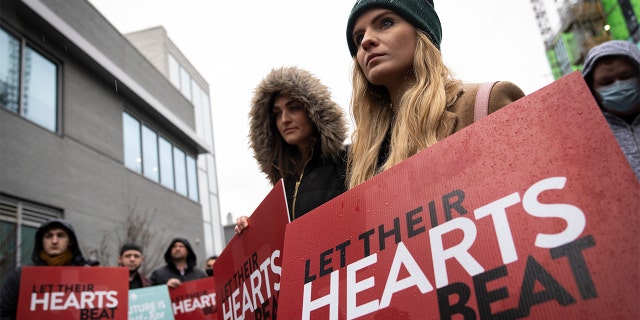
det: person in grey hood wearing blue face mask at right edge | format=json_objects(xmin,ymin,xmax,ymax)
[{"xmin": 582, "ymin": 40, "xmax": 640, "ymax": 181}]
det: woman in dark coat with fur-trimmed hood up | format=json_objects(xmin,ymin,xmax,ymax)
[{"xmin": 249, "ymin": 67, "xmax": 347, "ymax": 220}]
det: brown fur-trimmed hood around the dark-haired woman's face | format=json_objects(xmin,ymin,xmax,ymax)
[{"xmin": 249, "ymin": 67, "xmax": 347, "ymax": 180}]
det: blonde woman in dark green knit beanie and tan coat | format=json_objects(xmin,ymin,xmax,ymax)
[{"xmin": 346, "ymin": 0, "xmax": 524, "ymax": 188}]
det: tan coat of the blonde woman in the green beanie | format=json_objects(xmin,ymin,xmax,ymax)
[{"xmin": 436, "ymin": 81, "xmax": 524, "ymax": 141}]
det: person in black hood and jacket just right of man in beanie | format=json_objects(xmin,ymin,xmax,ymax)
[{"xmin": 150, "ymin": 238, "xmax": 207, "ymax": 288}]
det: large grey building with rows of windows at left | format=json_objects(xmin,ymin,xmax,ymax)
[{"xmin": 0, "ymin": 0, "xmax": 225, "ymax": 275}]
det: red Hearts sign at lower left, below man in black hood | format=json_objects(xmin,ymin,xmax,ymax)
[{"xmin": 16, "ymin": 267, "xmax": 129, "ymax": 320}]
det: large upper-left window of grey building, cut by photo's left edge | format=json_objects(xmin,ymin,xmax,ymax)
[{"xmin": 0, "ymin": 28, "xmax": 58, "ymax": 132}]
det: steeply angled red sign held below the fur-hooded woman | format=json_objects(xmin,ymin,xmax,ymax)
[{"xmin": 213, "ymin": 180, "xmax": 289, "ymax": 320}]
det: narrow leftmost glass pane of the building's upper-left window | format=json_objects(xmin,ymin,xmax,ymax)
[{"xmin": 0, "ymin": 29, "xmax": 20, "ymax": 113}]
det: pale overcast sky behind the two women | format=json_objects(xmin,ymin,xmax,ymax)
[{"xmin": 90, "ymin": 0, "xmax": 554, "ymax": 223}]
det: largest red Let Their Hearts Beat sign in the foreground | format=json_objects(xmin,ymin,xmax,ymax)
[{"xmin": 279, "ymin": 73, "xmax": 640, "ymax": 319}]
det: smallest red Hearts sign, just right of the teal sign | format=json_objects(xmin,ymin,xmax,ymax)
[{"xmin": 169, "ymin": 277, "xmax": 218, "ymax": 320}]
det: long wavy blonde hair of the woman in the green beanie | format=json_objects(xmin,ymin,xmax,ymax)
[{"xmin": 347, "ymin": 31, "xmax": 462, "ymax": 189}]
